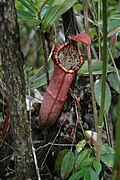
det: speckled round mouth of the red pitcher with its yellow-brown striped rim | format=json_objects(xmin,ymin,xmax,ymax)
[{"xmin": 52, "ymin": 40, "xmax": 84, "ymax": 73}]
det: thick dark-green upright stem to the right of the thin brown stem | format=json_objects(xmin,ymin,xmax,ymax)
[{"xmin": 96, "ymin": 0, "xmax": 107, "ymax": 161}]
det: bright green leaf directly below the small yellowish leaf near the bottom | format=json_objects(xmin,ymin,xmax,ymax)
[{"xmin": 75, "ymin": 149, "xmax": 91, "ymax": 170}]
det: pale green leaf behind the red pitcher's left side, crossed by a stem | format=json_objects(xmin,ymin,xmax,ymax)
[{"xmin": 29, "ymin": 69, "xmax": 53, "ymax": 90}]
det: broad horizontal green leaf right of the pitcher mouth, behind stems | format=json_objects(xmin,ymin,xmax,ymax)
[{"xmin": 78, "ymin": 60, "xmax": 115, "ymax": 76}]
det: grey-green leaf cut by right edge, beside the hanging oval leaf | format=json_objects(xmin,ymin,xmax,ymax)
[{"xmin": 107, "ymin": 73, "xmax": 120, "ymax": 94}]
